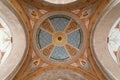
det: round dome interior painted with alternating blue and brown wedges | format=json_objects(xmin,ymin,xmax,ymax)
[{"xmin": 36, "ymin": 15, "xmax": 83, "ymax": 62}]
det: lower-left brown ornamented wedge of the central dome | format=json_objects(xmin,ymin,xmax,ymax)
[{"xmin": 42, "ymin": 44, "xmax": 54, "ymax": 57}]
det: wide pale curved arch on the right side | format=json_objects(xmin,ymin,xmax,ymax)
[{"xmin": 90, "ymin": 0, "xmax": 120, "ymax": 80}]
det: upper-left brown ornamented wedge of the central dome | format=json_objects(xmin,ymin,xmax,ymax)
[{"xmin": 40, "ymin": 19, "xmax": 55, "ymax": 34}]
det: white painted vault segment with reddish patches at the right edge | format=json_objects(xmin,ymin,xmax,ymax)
[{"xmin": 108, "ymin": 18, "xmax": 120, "ymax": 64}]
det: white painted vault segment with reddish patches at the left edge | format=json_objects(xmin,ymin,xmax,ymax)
[{"xmin": 0, "ymin": 18, "xmax": 12, "ymax": 64}]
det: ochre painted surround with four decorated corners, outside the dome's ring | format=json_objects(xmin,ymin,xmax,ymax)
[{"xmin": 10, "ymin": 0, "xmax": 110, "ymax": 80}]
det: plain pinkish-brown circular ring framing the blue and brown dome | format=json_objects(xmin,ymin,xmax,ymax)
[{"xmin": 33, "ymin": 11, "xmax": 87, "ymax": 64}]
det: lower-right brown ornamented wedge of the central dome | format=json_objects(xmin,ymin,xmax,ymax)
[{"xmin": 65, "ymin": 44, "xmax": 79, "ymax": 57}]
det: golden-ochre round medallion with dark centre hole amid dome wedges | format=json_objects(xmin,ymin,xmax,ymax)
[{"xmin": 52, "ymin": 32, "xmax": 67, "ymax": 46}]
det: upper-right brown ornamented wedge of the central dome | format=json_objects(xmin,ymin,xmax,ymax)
[{"xmin": 65, "ymin": 19, "xmax": 80, "ymax": 34}]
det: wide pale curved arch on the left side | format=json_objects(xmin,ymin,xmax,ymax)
[{"xmin": 0, "ymin": 0, "xmax": 29, "ymax": 80}]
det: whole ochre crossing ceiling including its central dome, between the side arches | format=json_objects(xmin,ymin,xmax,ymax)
[{"xmin": 12, "ymin": 0, "xmax": 109, "ymax": 80}]
